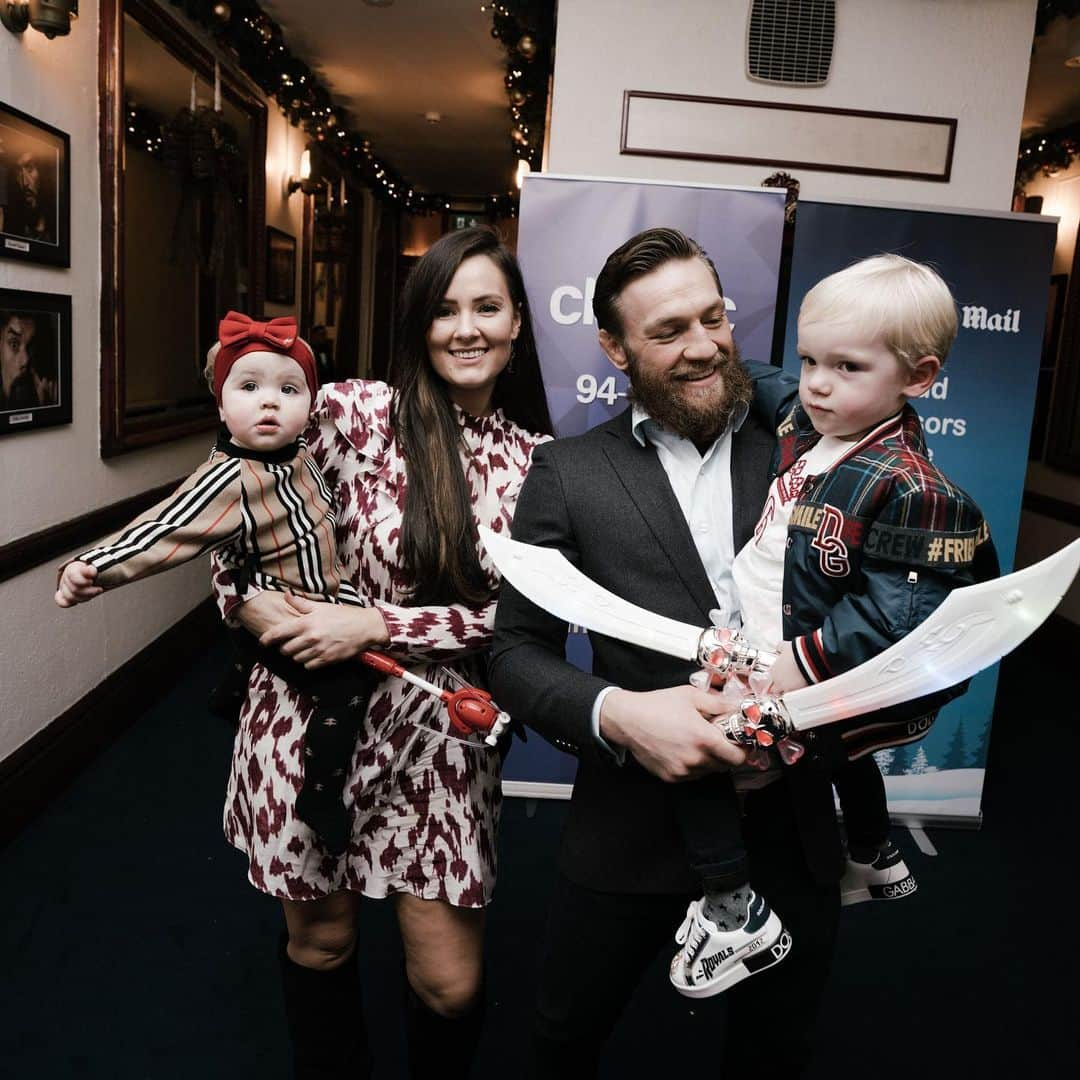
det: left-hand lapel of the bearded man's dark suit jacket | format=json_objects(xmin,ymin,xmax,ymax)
[{"xmin": 604, "ymin": 419, "xmax": 716, "ymax": 625}]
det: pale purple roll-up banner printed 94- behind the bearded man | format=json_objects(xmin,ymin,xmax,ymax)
[{"xmin": 502, "ymin": 174, "xmax": 785, "ymax": 797}]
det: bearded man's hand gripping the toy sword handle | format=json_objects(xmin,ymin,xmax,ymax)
[{"xmin": 600, "ymin": 686, "xmax": 746, "ymax": 783}]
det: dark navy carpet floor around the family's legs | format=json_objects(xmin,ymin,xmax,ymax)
[{"xmin": 0, "ymin": 631, "xmax": 1080, "ymax": 1080}]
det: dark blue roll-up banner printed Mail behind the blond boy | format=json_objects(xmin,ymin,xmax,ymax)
[{"xmin": 783, "ymin": 200, "xmax": 1056, "ymax": 825}]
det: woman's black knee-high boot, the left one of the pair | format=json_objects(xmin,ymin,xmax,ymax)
[{"xmin": 279, "ymin": 934, "xmax": 372, "ymax": 1080}]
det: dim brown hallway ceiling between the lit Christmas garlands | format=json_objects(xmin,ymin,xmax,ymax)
[{"xmin": 261, "ymin": 0, "xmax": 515, "ymax": 195}]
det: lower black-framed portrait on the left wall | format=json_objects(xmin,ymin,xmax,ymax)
[{"xmin": 0, "ymin": 288, "xmax": 71, "ymax": 436}]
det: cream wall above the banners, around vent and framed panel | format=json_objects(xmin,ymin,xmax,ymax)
[{"xmin": 546, "ymin": 0, "xmax": 1036, "ymax": 210}]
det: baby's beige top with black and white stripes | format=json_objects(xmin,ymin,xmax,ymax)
[{"xmin": 69, "ymin": 431, "xmax": 361, "ymax": 604}]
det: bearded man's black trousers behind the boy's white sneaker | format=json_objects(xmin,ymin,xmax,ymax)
[{"xmin": 531, "ymin": 782, "xmax": 839, "ymax": 1080}]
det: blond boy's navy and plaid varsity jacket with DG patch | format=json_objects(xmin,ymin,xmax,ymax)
[{"xmin": 746, "ymin": 363, "xmax": 999, "ymax": 759}]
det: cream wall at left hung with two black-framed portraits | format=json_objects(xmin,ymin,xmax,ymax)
[{"xmin": 0, "ymin": 0, "xmax": 311, "ymax": 758}]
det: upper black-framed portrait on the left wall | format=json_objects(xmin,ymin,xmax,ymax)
[{"xmin": 0, "ymin": 102, "xmax": 71, "ymax": 267}]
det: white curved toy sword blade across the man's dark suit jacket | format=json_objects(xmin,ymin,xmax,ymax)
[{"xmin": 480, "ymin": 525, "xmax": 704, "ymax": 661}]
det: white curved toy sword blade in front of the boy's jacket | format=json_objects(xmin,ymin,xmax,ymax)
[{"xmin": 780, "ymin": 540, "xmax": 1080, "ymax": 730}]
